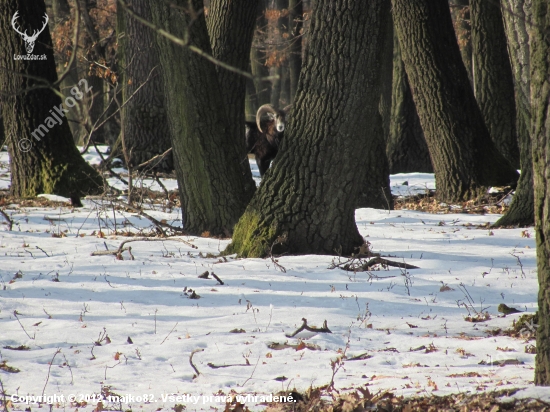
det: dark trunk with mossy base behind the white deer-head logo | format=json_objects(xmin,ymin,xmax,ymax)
[{"xmin": 0, "ymin": 0, "xmax": 102, "ymax": 197}]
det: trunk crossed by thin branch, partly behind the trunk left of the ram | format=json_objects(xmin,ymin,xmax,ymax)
[{"xmin": 206, "ymin": 0, "xmax": 258, "ymax": 198}]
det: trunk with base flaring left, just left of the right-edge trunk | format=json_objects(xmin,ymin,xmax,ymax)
[{"xmin": 494, "ymin": 0, "xmax": 535, "ymax": 226}]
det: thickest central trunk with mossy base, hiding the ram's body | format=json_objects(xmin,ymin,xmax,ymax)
[{"xmin": 227, "ymin": 0, "xmax": 389, "ymax": 257}]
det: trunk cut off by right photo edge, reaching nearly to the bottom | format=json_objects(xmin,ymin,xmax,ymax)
[{"xmin": 531, "ymin": 0, "xmax": 550, "ymax": 386}]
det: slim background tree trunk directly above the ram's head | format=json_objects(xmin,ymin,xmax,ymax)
[{"xmin": 250, "ymin": 0, "xmax": 271, "ymax": 106}]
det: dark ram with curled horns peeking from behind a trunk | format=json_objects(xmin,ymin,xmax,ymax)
[{"xmin": 246, "ymin": 104, "xmax": 287, "ymax": 177}]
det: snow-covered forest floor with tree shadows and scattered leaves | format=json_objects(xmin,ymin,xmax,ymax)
[{"xmin": 0, "ymin": 147, "xmax": 550, "ymax": 411}]
